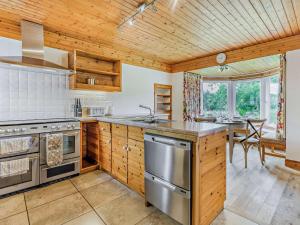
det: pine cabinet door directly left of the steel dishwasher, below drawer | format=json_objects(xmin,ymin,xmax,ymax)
[{"xmin": 128, "ymin": 139, "xmax": 145, "ymax": 195}]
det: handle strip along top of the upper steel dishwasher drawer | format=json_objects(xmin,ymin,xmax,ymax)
[{"xmin": 144, "ymin": 134, "xmax": 191, "ymax": 150}]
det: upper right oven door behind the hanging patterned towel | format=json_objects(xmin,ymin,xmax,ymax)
[{"xmin": 40, "ymin": 130, "xmax": 80, "ymax": 165}]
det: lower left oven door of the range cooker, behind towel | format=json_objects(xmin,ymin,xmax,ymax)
[{"xmin": 0, "ymin": 153, "xmax": 39, "ymax": 195}]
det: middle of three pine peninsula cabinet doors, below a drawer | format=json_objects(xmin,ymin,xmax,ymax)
[{"xmin": 112, "ymin": 135, "xmax": 127, "ymax": 184}]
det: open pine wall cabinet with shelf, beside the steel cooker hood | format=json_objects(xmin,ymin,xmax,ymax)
[{"xmin": 69, "ymin": 50, "xmax": 122, "ymax": 92}]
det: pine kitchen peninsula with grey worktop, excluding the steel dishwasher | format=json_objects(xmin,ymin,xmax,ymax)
[{"xmin": 81, "ymin": 117, "xmax": 227, "ymax": 225}]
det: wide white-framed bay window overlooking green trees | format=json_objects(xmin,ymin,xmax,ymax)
[{"xmin": 202, "ymin": 75, "xmax": 279, "ymax": 128}]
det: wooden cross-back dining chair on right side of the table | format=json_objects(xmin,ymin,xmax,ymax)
[{"xmin": 233, "ymin": 119, "xmax": 266, "ymax": 168}]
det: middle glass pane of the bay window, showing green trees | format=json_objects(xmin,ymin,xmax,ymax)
[{"xmin": 235, "ymin": 81, "xmax": 261, "ymax": 118}]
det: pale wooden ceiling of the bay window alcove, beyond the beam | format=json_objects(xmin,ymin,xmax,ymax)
[{"xmin": 191, "ymin": 55, "xmax": 280, "ymax": 78}]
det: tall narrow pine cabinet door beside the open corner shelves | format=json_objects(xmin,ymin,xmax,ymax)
[{"xmin": 99, "ymin": 122, "xmax": 112, "ymax": 173}]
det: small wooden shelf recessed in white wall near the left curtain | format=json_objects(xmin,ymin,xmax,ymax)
[{"xmin": 154, "ymin": 84, "xmax": 172, "ymax": 119}]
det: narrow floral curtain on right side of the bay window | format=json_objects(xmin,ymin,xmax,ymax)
[{"xmin": 276, "ymin": 55, "xmax": 286, "ymax": 139}]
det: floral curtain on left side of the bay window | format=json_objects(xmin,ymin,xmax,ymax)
[{"xmin": 183, "ymin": 72, "xmax": 201, "ymax": 121}]
